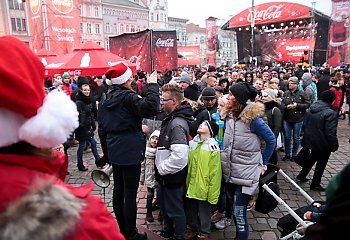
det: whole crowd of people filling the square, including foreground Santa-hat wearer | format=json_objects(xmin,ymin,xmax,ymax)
[{"xmin": 0, "ymin": 34, "xmax": 350, "ymax": 240}]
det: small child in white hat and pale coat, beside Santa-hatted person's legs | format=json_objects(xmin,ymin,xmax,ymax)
[{"xmin": 140, "ymin": 130, "xmax": 160, "ymax": 222}]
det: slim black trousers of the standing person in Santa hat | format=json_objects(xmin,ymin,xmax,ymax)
[{"xmin": 112, "ymin": 164, "xmax": 141, "ymax": 237}]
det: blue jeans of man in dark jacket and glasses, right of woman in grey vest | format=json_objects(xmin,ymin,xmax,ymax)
[{"xmin": 283, "ymin": 121, "xmax": 303, "ymax": 157}]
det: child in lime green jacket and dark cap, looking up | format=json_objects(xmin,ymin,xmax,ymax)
[{"xmin": 185, "ymin": 120, "xmax": 222, "ymax": 239}]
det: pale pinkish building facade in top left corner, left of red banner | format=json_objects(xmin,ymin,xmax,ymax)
[{"xmin": 0, "ymin": 0, "xmax": 32, "ymax": 46}]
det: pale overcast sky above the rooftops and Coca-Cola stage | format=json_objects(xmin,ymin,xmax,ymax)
[{"xmin": 168, "ymin": 0, "xmax": 332, "ymax": 27}]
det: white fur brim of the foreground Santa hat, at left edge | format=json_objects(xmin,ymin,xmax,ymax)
[{"xmin": 0, "ymin": 108, "xmax": 26, "ymax": 147}]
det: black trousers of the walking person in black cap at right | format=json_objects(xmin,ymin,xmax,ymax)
[{"xmin": 299, "ymin": 149, "xmax": 331, "ymax": 187}]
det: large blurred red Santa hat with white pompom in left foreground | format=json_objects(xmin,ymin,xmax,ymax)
[{"xmin": 0, "ymin": 36, "xmax": 78, "ymax": 148}]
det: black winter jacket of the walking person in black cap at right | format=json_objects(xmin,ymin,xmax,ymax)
[{"xmin": 301, "ymin": 100, "xmax": 339, "ymax": 152}]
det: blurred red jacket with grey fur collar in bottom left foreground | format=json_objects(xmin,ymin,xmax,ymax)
[{"xmin": 0, "ymin": 153, "xmax": 124, "ymax": 240}]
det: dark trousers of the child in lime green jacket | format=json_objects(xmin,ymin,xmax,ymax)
[{"xmin": 186, "ymin": 198, "xmax": 211, "ymax": 234}]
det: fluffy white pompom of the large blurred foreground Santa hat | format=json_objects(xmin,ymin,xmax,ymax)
[{"xmin": 18, "ymin": 91, "xmax": 79, "ymax": 148}]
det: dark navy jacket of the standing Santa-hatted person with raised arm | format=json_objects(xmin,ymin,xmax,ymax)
[{"xmin": 99, "ymin": 83, "xmax": 160, "ymax": 165}]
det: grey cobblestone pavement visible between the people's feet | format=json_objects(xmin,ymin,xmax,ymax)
[{"xmin": 66, "ymin": 120, "xmax": 350, "ymax": 240}]
